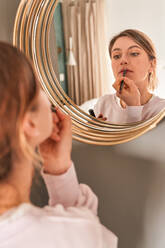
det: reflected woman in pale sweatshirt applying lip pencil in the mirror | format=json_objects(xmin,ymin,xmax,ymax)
[{"xmin": 94, "ymin": 29, "xmax": 165, "ymax": 124}]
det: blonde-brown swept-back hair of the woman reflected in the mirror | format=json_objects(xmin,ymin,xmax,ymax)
[{"xmin": 109, "ymin": 29, "xmax": 158, "ymax": 91}]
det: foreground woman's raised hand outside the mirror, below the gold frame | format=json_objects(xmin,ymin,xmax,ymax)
[{"xmin": 39, "ymin": 108, "xmax": 72, "ymax": 175}]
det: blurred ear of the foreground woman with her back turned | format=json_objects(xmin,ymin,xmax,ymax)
[{"xmin": 23, "ymin": 111, "xmax": 40, "ymax": 138}]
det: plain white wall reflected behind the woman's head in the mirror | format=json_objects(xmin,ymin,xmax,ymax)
[{"xmin": 106, "ymin": 0, "xmax": 165, "ymax": 98}]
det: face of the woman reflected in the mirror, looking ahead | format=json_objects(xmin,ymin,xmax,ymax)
[{"xmin": 111, "ymin": 37, "xmax": 152, "ymax": 87}]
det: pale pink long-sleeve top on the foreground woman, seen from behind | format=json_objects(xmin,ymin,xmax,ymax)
[{"xmin": 0, "ymin": 165, "xmax": 117, "ymax": 248}]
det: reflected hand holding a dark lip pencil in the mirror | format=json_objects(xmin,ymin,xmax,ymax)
[{"xmin": 113, "ymin": 77, "xmax": 141, "ymax": 106}]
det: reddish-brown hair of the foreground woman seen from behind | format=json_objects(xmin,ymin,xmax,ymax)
[{"xmin": 0, "ymin": 42, "xmax": 39, "ymax": 180}]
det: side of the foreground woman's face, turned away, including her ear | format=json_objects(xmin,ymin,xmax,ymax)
[{"xmin": 23, "ymin": 89, "xmax": 60, "ymax": 147}]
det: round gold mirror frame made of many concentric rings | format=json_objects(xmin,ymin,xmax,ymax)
[{"xmin": 13, "ymin": 0, "xmax": 165, "ymax": 145}]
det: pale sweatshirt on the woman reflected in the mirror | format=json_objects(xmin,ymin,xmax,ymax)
[{"xmin": 94, "ymin": 94, "xmax": 165, "ymax": 124}]
